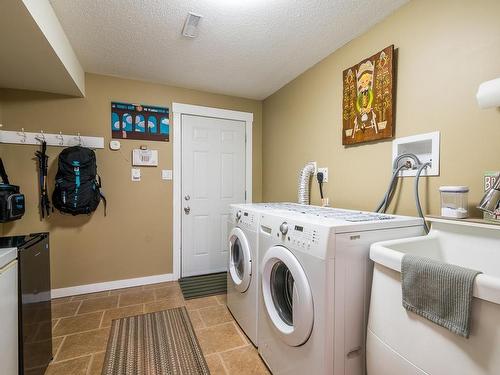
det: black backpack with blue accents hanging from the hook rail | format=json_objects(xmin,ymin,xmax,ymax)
[{"xmin": 52, "ymin": 146, "xmax": 106, "ymax": 215}]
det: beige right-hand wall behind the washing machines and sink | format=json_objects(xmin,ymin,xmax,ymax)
[{"xmin": 262, "ymin": 0, "xmax": 500, "ymax": 215}]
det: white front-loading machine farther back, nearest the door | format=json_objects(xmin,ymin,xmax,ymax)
[{"xmin": 227, "ymin": 203, "xmax": 316, "ymax": 346}]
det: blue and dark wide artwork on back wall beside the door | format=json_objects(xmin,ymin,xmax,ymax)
[{"xmin": 111, "ymin": 102, "xmax": 170, "ymax": 142}]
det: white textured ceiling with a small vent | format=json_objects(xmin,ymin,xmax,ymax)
[{"xmin": 50, "ymin": 0, "xmax": 407, "ymax": 99}]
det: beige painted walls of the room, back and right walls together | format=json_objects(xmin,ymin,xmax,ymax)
[{"xmin": 0, "ymin": 0, "xmax": 500, "ymax": 288}]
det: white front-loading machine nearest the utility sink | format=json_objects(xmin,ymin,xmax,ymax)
[{"xmin": 258, "ymin": 207, "xmax": 423, "ymax": 375}]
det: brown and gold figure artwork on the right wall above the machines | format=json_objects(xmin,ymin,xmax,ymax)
[{"xmin": 342, "ymin": 46, "xmax": 395, "ymax": 145}]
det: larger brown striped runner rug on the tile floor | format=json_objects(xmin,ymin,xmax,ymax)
[{"xmin": 102, "ymin": 307, "xmax": 210, "ymax": 375}]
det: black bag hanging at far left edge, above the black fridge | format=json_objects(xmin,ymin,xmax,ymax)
[{"xmin": 0, "ymin": 158, "xmax": 26, "ymax": 223}]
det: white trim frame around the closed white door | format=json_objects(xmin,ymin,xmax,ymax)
[{"xmin": 172, "ymin": 103, "xmax": 253, "ymax": 280}]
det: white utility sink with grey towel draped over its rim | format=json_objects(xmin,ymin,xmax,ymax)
[{"xmin": 367, "ymin": 218, "xmax": 500, "ymax": 375}]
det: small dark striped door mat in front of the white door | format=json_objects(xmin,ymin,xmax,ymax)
[{"xmin": 179, "ymin": 272, "xmax": 227, "ymax": 299}]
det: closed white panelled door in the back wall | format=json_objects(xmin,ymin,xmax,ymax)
[{"xmin": 181, "ymin": 115, "xmax": 245, "ymax": 277}]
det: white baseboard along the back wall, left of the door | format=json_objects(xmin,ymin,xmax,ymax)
[{"xmin": 51, "ymin": 273, "xmax": 176, "ymax": 298}]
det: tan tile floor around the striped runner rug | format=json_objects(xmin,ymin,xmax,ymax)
[{"xmin": 33, "ymin": 282, "xmax": 269, "ymax": 375}]
